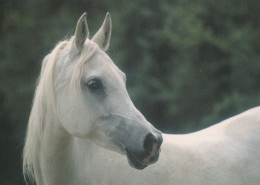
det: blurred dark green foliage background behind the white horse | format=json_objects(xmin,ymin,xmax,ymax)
[{"xmin": 0, "ymin": 0, "xmax": 260, "ymax": 185}]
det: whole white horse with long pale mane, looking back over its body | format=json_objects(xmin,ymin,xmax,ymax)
[{"xmin": 23, "ymin": 14, "xmax": 260, "ymax": 185}]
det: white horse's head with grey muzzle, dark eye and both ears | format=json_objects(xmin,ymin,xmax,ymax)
[{"xmin": 54, "ymin": 13, "xmax": 162, "ymax": 169}]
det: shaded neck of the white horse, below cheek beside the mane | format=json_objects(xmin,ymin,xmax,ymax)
[{"xmin": 34, "ymin": 122, "xmax": 73, "ymax": 185}]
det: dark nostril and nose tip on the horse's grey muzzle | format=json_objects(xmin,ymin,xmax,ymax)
[{"xmin": 143, "ymin": 133, "xmax": 162, "ymax": 154}]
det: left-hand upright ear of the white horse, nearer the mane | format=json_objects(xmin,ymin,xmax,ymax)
[{"xmin": 74, "ymin": 12, "xmax": 89, "ymax": 52}]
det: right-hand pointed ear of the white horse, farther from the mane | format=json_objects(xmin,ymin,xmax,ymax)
[{"xmin": 92, "ymin": 13, "xmax": 112, "ymax": 51}]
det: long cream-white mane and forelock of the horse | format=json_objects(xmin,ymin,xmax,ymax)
[{"xmin": 23, "ymin": 37, "xmax": 97, "ymax": 181}]
